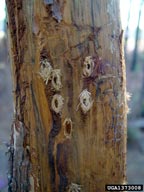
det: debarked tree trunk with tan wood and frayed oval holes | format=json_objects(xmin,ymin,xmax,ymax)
[{"xmin": 6, "ymin": 0, "xmax": 126, "ymax": 192}]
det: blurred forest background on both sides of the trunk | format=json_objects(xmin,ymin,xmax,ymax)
[{"xmin": 0, "ymin": 0, "xmax": 144, "ymax": 192}]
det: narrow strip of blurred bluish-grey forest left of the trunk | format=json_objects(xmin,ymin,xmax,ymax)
[{"xmin": 0, "ymin": 0, "xmax": 13, "ymax": 192}]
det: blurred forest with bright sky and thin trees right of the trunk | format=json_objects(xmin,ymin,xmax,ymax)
[{"xmin": 120, "ymin": 0, "xmax": 144, "ymax": 185}]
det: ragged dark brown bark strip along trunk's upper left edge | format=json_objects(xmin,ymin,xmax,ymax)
[{"xmin": 6, "ymin": 0, "xmax": 26, "ymax": 121}]
